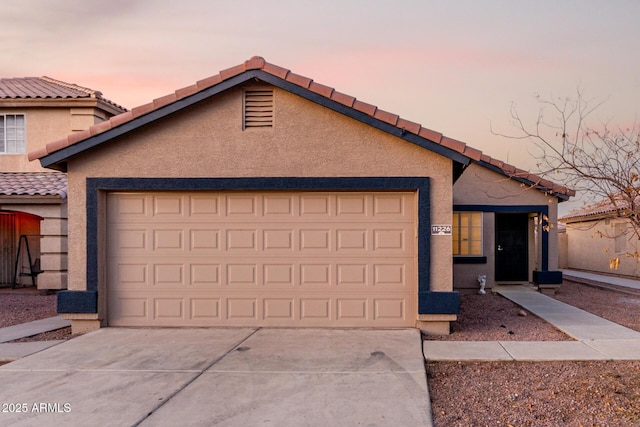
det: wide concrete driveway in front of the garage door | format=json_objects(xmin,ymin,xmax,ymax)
[{"xmin": 0, "ymin": 328, "xmax": 431, "ymax": 426}]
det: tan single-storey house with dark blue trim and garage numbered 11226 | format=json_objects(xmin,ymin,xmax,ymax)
[{"xmin": 29, "ymin": 57, "xmax": 572, "ymax": 334}]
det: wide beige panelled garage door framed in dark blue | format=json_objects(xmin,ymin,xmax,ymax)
[{"xmin": 107, "ymin": 192, "xmax": 417, "ymax": 327}]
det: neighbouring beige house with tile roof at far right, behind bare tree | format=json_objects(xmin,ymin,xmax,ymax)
[{"xmin": 559, "ymin": 196, "xmax": 640, "ymax": 277}]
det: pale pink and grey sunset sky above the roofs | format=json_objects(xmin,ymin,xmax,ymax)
[{"xmin": 0, "ymin": 0, "xmax": 640, "ymax": 212}]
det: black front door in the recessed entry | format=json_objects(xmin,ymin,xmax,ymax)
[{"xmin": 496, "ymin": 213, "xmax": 529, "ymax": 282}]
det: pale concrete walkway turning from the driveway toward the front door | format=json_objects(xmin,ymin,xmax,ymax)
[{"xmin": 423, "ymin": 276, "xmax": 640, "ymax": 361}]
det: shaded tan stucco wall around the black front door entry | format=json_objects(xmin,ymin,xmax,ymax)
[{"xmin": 453, "ymin": 163, "xmax": 558, "ymax": 291}]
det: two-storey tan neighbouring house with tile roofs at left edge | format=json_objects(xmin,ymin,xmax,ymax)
[{"xmin": 0, "ymin": 77, "xmax": 126, "ymax": 289}]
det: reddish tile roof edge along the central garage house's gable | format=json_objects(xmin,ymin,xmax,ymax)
[{"xmin": 29, "ymin": 56, "xmax": 575, "ymax": 199}]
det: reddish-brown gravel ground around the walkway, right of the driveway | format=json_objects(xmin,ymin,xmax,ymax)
[{"xmin": 427, "ymin": 281, "xmax": 640, "ymax": 427}]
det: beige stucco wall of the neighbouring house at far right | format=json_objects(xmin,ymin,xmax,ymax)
[{"xmin": 567, "ymin": 219, "xmax": 640, "ymax": 277}]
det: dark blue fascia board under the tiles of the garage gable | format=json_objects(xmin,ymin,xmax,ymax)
[{"xmin": 40, "ymin": 70, "xmax": 471, "ymax": 169}]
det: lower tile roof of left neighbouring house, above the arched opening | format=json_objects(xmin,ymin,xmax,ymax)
[{"xmin": 0, "ymin": 172, "xmax": 67, "ymax": 199}]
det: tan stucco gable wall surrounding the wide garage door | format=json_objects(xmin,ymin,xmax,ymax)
[{"xmin": 63, "ymin": 88, "xmax": 452, "ymax": 314}]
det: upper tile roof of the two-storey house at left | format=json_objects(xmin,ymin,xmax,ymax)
[{"xmin": 0, "ymin": 76, "xmax": 127, "ymax": 112}]
